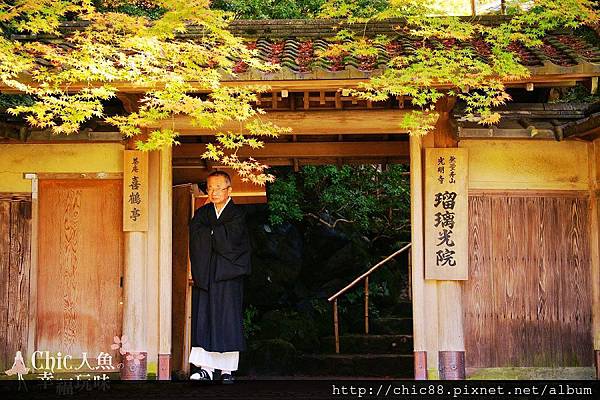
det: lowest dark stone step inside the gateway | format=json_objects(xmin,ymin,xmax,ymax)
[{"xmin": 295, "ymin": 354, "xmax": 414, "ymax": 379}]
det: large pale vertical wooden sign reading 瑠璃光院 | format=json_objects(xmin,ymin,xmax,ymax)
[{"xmin": 424, "ymin": 147, "xmax": 469, "ymax": 280}]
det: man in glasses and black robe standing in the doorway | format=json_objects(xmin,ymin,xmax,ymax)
[{"xmin": 189, "ymin": 171, "xmax": 251, "ymax": 383}]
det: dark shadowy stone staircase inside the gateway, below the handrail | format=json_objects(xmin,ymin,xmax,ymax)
[{"xmin": 237, "ymin": 303, "xmax": 414, "ymax": 379}]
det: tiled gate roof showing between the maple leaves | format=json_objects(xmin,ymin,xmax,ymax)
[{"xmin": 14, "ymin": 16, "xmax": 600, "ymax": 80}]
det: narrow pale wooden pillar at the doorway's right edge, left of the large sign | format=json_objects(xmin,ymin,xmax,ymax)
[{"xmin": 409, "ymin": 135, "xmax": 428, "ymax": 380}]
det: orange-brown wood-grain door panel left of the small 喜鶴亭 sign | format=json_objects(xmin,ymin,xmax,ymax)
[{"xmin": 36, "ymin": 179, "xmax": 123, "ymax": 359}]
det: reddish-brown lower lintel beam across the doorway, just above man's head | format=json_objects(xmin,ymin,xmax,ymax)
[{"xmin": 173, "ymin": 141, "xmax": 409, "ymax": 159}]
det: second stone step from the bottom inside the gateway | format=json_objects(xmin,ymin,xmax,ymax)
[{"xmin": 321, "ymin": 334, "xmax": 413, "ymax": 354}]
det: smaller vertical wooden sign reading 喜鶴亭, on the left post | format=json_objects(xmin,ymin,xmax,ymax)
[{"xmin": 123, "ymin": 150, "xmax": 148, "ymax": 232}]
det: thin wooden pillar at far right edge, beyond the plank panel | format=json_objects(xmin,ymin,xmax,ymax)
[{"xmin": 588, "ymin": 139, "xmax": 600, "ymax": 379}]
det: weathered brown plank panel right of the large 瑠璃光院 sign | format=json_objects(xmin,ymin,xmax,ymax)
[{"xmin": 463, "ymin": 192, "xmax": 594, "ymax": 367}]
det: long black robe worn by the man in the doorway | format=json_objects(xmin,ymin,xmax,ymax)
[{"xmin": 190, "ymin": 200, "xmax": 251, "ymax": 352}]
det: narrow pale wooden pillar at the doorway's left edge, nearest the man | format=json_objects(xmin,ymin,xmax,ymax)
[{"xmin": 158, "ymin": 146, "xmax": 173, "ymax": 380}]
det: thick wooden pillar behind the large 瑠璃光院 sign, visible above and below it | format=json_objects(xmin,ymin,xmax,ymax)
[{"xmin": 434, "ymin": 96, "xmax": 466, "ymax": 380}]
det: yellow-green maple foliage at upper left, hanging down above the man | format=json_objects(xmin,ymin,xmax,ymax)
[{"xmin": 0, "ymin": 0, "xmax": 285, "ymax": 184}]
